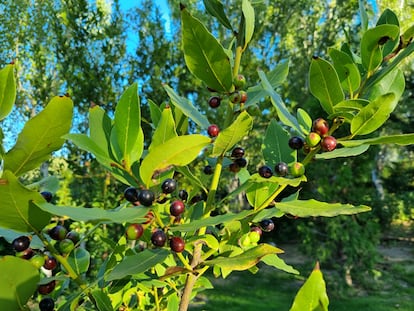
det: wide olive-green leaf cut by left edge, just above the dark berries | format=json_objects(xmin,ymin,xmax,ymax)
[{"xmin": 0, "ymin": 171, "xmax": 50, "ymax": 232}]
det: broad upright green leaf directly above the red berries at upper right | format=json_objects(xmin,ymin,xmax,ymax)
[{"xmin": 309, "ymin": 57, "xmax": 345, "ymax": 114}]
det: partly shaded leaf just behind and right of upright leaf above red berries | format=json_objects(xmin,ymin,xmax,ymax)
[{"xmin": 329, "ymin": 48, "xmax": 361, "ymax": 93}]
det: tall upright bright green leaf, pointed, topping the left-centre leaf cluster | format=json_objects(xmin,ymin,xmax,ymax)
[{"xmin": 114, "ymin": 83, "xmax": 141, "ymax": 164}]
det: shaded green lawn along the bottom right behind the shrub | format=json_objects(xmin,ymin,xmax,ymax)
[{"xmin": 190, "ymin": 245, "xmax": 414, "ymax": 311}]
